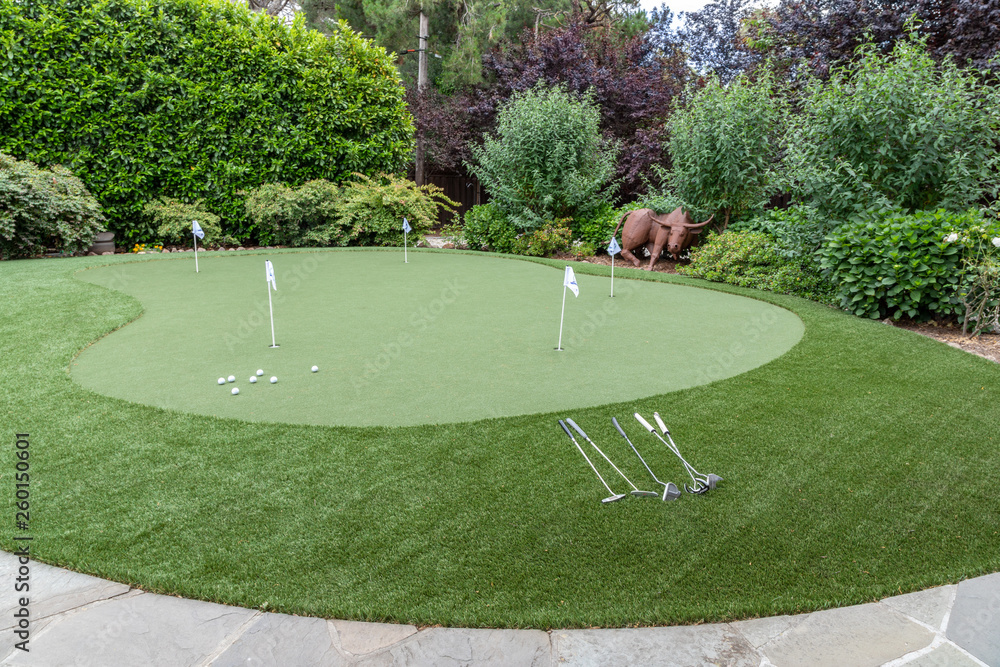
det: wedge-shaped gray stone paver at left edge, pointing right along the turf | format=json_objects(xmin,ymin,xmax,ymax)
[{"xmin": 0, "ymin": 552, "xmax": 129, "ymax": 631}]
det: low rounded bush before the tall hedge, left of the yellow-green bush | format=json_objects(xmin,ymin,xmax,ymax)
[{"xmin": 244, "ymin": 179, "xmax": 350, "ymax": 246}]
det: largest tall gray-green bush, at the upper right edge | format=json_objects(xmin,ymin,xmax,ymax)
[{"xmin": 786, "ymin": 33, "xmax": 1000, "ymax": 220}]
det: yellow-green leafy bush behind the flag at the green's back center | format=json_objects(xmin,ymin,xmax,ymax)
[{"xmin": 336, "ymin": 174, "xmax": 458, "ymax": 246}]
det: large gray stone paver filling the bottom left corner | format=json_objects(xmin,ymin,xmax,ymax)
[{"xmin": 5, "ymin": 593, "xmax": 259, "ymax": 667}]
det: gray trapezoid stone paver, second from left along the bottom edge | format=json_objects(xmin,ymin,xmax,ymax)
[{"xmin": 211, "ymin": 614, "xmax": 348, "ymax": 667}]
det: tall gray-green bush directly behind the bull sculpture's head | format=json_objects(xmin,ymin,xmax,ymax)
[{"xmin": 667, "ymin": 72, "xmax": 786, "ymax": 229}]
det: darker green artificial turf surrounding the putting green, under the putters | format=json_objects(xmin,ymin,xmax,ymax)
[{"xmin": 0, "ymin": 248, "xmax": 1000, "ymax": 628}]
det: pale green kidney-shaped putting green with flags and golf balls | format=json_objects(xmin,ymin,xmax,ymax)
[{"xmin": 72, "ymin": 251, "xmax": 804, "ymax": 426}]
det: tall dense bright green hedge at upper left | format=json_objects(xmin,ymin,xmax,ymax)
[{"xmin": 0, "ymin": 0, "xmax": 413, "ymax": 240}]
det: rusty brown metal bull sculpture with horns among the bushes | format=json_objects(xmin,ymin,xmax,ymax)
[{"xmin": 614, "ymin": 206, "xmax": 715, "ymax": 271}]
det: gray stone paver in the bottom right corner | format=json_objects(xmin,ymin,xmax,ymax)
[{"xmin": 948, "ymin": 573, "xmax": 1000, "ymax": 665}]
